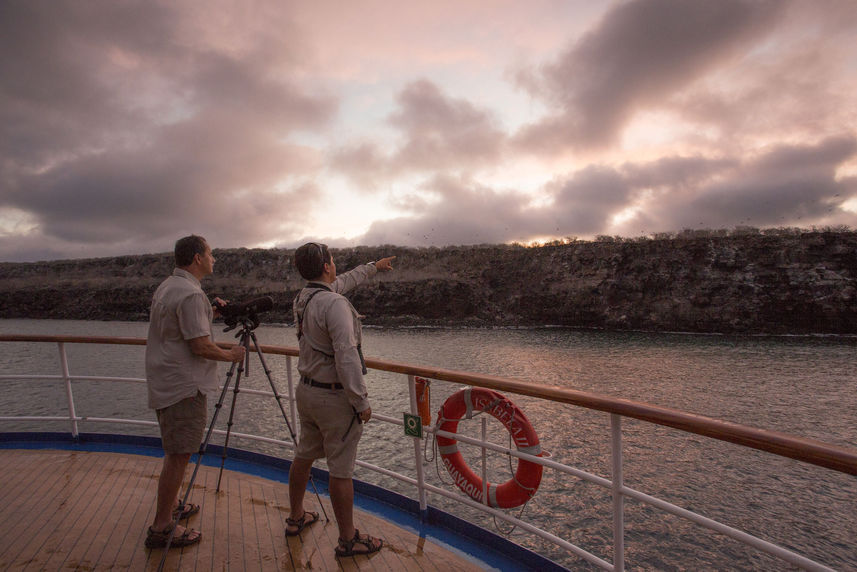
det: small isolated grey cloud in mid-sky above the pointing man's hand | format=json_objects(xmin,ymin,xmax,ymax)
[{"xmin": 331, "ymin": 80, "xmax": 506, "ymax": 186}]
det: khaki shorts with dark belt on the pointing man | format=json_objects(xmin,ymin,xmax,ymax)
[{"xmin": 295, "ymin": 383, "xmax": 363, "ymax": 479}]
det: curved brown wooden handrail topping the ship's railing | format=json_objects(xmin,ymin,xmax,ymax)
[{"xmin": 0, "ymin": 334, "xmax": 857, "ymax": 475}]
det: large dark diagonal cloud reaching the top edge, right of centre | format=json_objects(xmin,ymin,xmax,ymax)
[{"xmin": 517, "ymin": 0, "xmax": 785, "ymax": 151}]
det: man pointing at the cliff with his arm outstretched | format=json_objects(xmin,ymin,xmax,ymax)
[{"xmin": 286, "ymin": 242, "xmax": 395, "ymax": 556}]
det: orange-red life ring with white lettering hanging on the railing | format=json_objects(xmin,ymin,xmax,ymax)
[{"xmin": 436, "ymin": 387, "xmax": 542, "ymax": 508}]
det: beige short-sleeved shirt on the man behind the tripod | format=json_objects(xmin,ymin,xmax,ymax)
[{"xmin": 146, "ymin": 268, "xmax": 217, "ymax": 409}]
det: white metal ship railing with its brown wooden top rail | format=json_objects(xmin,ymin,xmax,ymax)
[{"xmin": 0, "ymin": 335, "xmax": 857, "ymax": 572}]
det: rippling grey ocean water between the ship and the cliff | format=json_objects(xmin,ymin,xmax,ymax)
[{"xmin": 0, "ymin": 320, "xmax": 857, "ymax": 570}]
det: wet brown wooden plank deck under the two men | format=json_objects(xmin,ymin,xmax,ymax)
[{"xmin": 0, "ymin": 450, "xmax": 480, "ymax": 571}]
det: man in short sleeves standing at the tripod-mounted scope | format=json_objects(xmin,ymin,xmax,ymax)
[{"xmin": 146, "ymin": 235, "xmax": 244, "ymax": 548}]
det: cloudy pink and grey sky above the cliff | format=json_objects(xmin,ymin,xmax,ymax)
[{"xmin": 0, "ymin": 0, "xmax": 857, "ymax": 261}]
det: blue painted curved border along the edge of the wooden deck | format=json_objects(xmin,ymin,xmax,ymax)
[{"xmin": 0, "ymin": 432, "xmax": 567, "ymax": 571}]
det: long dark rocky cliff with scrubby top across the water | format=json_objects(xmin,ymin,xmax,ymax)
[{"xmin": 0, "ymin": 232, "xmax": 857, "ymax": 334}]
